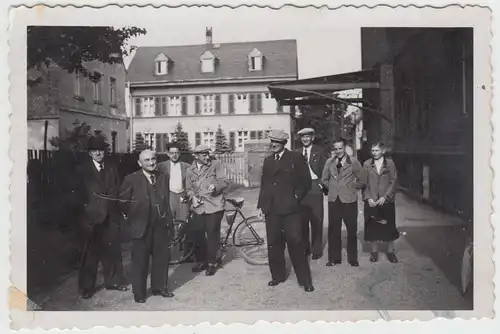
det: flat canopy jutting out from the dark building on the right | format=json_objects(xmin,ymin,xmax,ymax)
[{"xmin": 268, "ymin": 70, "xmax": 380, "ymax": 105}]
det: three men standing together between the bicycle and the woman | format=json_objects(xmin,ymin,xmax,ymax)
[{"xmin": 257, "ymin": 128, "xmax": 363, "ymax": 292}]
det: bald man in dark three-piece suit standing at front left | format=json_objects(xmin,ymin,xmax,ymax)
[{"xmin": 120, "ymin": 150, "xmax": 174, "ymax": 303}]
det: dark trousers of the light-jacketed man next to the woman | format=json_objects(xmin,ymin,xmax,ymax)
[{"xmin": 328, "ymin": 197, "xmax": 358, "ymax": 261}]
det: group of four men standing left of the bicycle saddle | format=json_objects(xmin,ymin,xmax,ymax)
[{"xmin": 76, "ymin": 137, "xmax": 229, "ymax": 303}]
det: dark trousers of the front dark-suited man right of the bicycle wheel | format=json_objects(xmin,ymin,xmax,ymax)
[{"xmin": 266, "ymin": 213, "xmax": 312, "ymax": 285}]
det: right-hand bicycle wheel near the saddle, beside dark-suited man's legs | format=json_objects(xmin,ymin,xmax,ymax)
[{"xmin": 233, "ymin": 216, "xmax": 269, "ymax": 265}]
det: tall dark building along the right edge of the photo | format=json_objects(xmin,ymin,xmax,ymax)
[{"xmin": 362, "ymin": 28, "xmax": 473, "ymax": 219}]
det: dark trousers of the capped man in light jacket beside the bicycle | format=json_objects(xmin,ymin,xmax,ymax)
[{"xmin": 193, "ymin": 211, "xmax": 224, "ymax": 265}]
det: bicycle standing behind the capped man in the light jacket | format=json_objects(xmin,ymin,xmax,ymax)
[{"xmin": 169, "ymin": 198, "xmax": 268, "ymax": 265}]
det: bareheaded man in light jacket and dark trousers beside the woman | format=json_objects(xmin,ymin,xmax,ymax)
[{"xmin": 321, "ymin": 139, "xmax": 364, "ymax": 267}]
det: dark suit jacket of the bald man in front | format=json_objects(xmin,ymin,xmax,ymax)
[{"xmin": 120, "ymin": 169, "xmax": 172, "ymax": 239}]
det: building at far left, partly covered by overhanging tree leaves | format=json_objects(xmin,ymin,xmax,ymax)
[{"xmin": 27, "ymin": 61, "xmax": 130, "ymax": 152}]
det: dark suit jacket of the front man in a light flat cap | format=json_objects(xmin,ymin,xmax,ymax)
[{"xmin": 257, "ymin": 149, "xmax": 311, "ymax": 215}]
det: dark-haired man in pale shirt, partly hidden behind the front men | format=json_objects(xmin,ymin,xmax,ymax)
[{"xmin": 158, "ymin": 142, "xmax": 194, "ymax": 260}]
